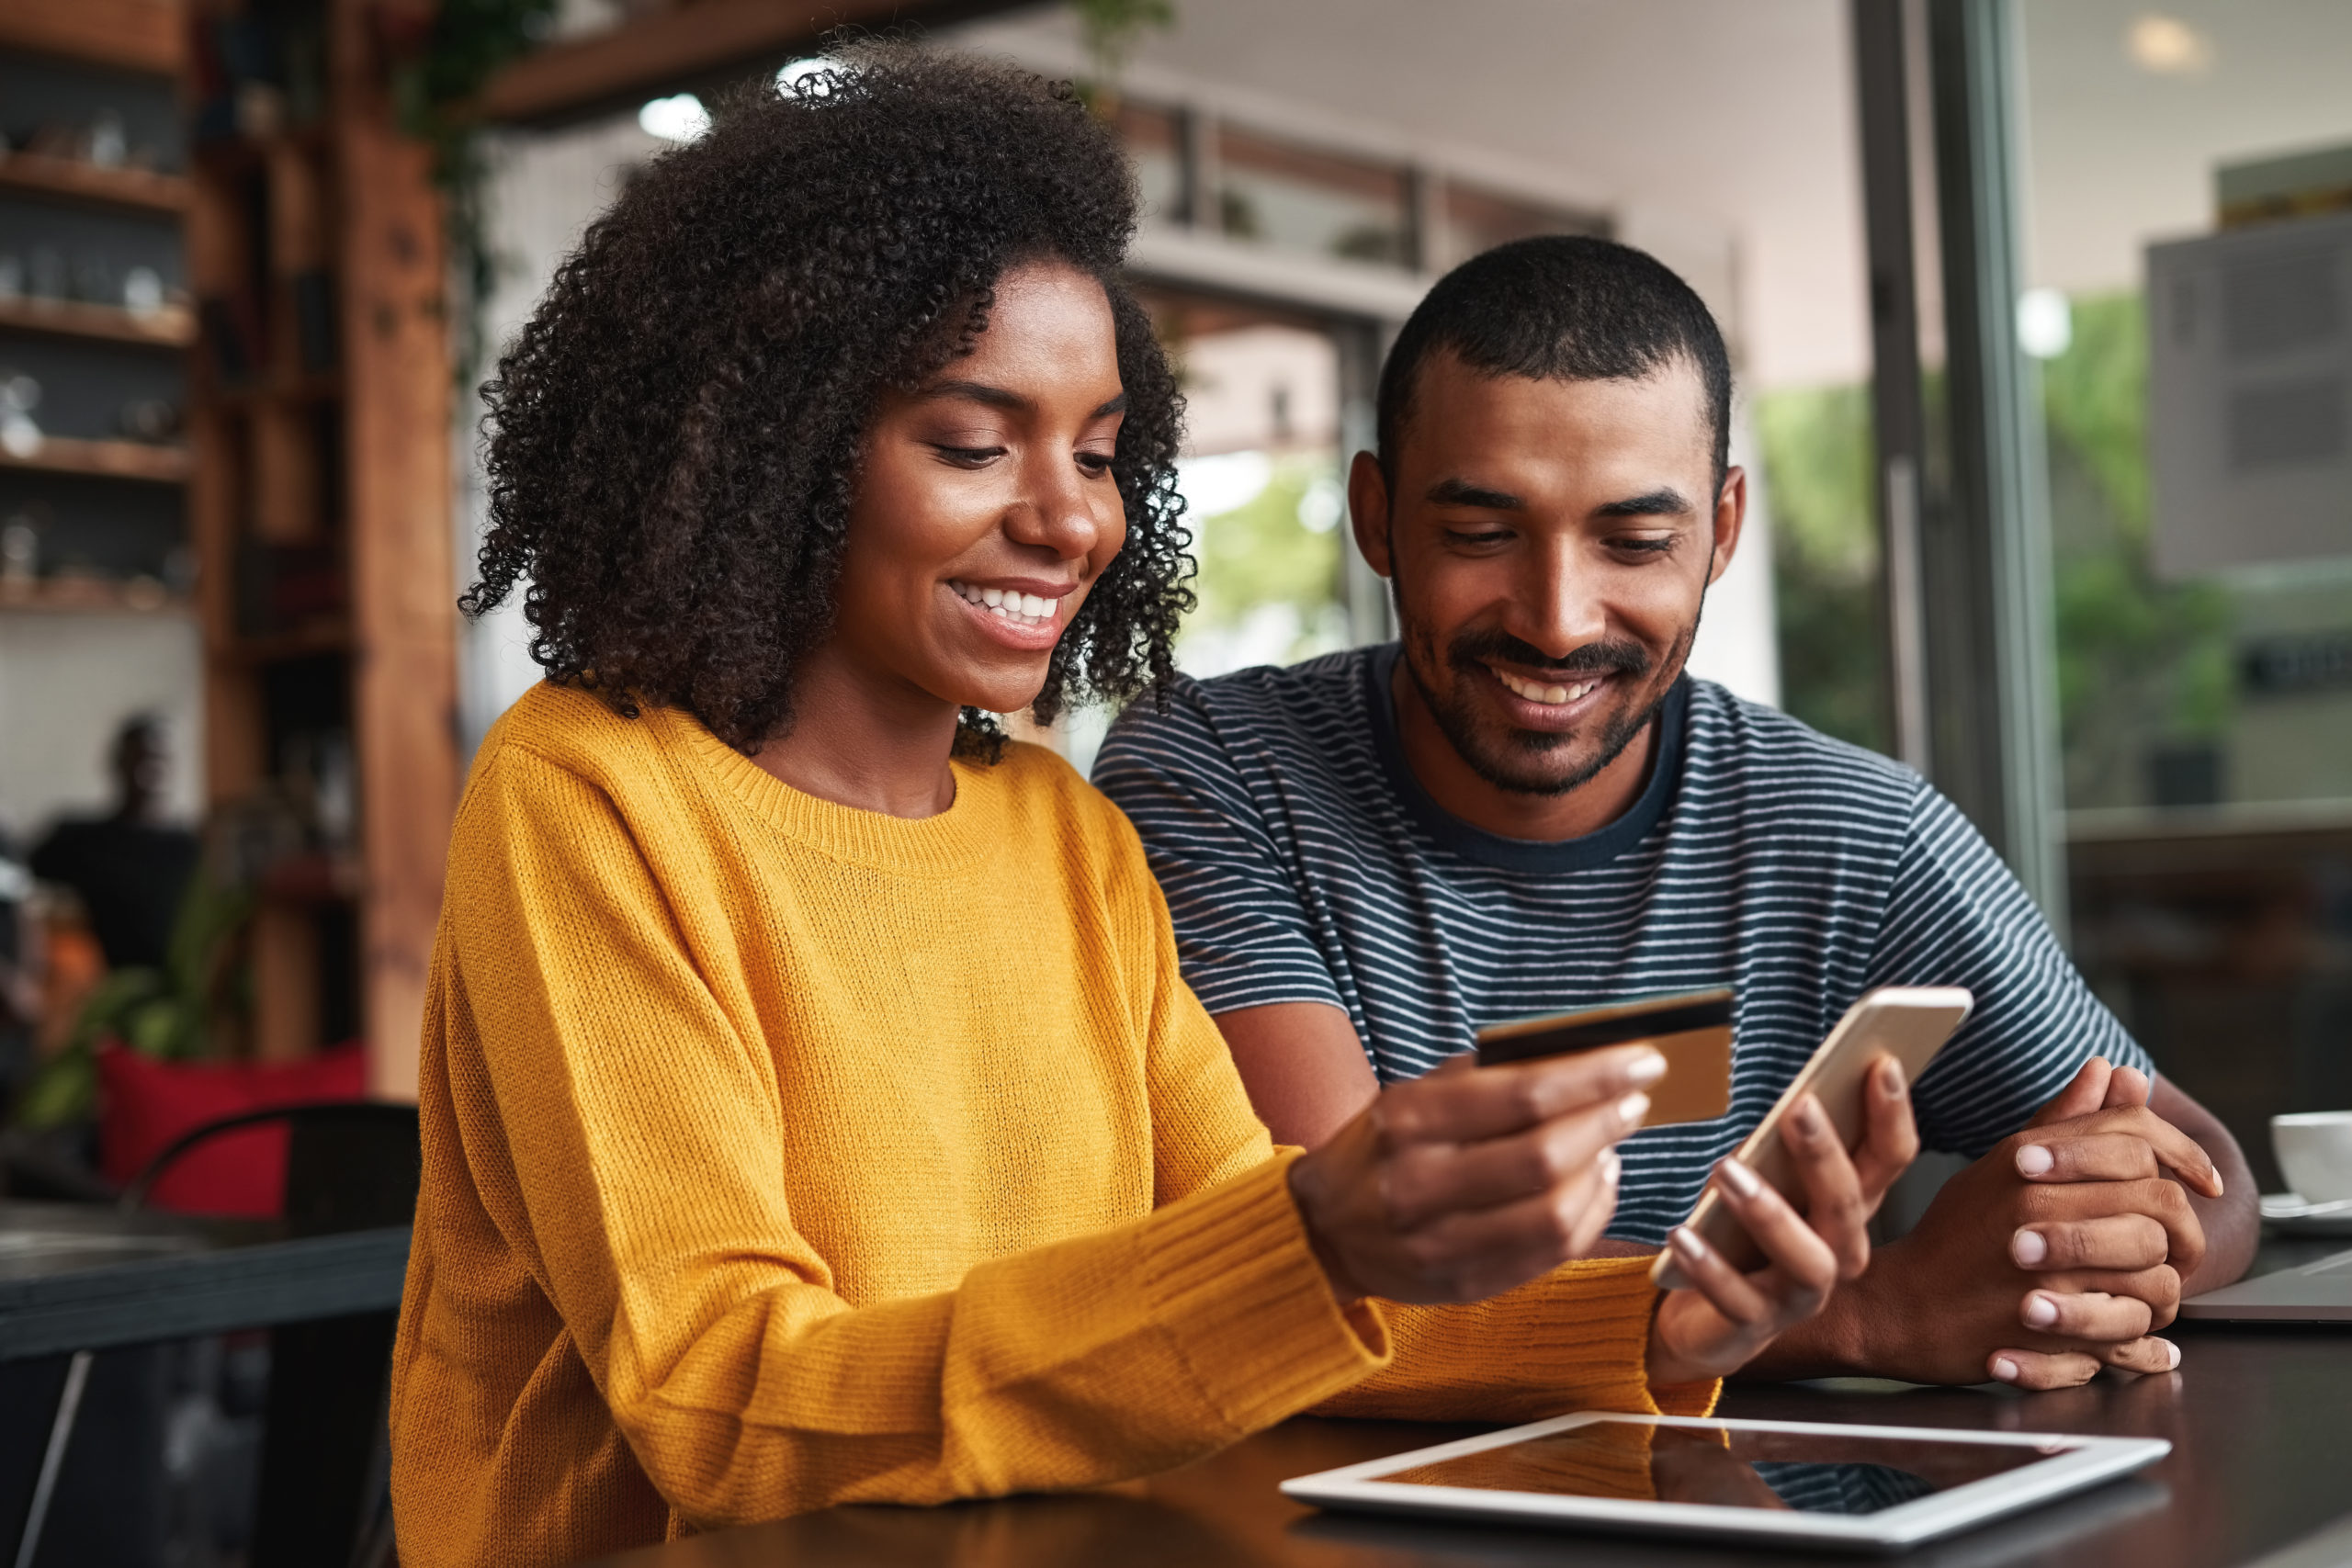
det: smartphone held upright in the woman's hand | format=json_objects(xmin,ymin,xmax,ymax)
[{"xmin": 1649, "ymin": 985, "xmax": 1975, "ymax": 1291}]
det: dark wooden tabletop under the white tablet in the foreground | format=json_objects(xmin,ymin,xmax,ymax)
[{"xmin": 582, "ymin": 1241, "xmax": 2352, "ymax": 1568}]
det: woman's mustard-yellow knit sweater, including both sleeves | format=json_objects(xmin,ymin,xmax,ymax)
[{"xmin": 393, "ymin": 686, "xmax": 1713, "ymax": 1568}]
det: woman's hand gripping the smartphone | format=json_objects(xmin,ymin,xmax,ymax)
[{"xmin": 1649, "ymin": 1055, "xmax": 1919, "ymax": 1384}]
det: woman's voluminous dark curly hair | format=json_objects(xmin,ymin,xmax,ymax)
[{"xmin": 461, "ymin": 45, "xmax": 1190, "ymax": 757}]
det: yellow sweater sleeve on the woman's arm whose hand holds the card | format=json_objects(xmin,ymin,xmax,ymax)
[{"xmin": 442, "ymin": 745, "xmax": 1385, "ymax": 1526}]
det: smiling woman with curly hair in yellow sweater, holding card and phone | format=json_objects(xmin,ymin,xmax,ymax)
[{"xmin": 393, "ymin": 51, "xmax": 1912, "ymax": 1568}]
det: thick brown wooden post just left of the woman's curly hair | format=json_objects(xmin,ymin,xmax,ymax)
[{"xmin": 332, "ymin": 0, "xmax": 458, "ymax": 1098}]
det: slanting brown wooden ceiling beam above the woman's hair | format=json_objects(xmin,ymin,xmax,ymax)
[{"xmin": 478, "ymin": 0, "xmax": 1040, "ymax": 125}]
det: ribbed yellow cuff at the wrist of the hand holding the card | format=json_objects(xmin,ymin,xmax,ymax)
[{"xmin": 1143, "ymin": 1149, "xmax": 1387, "ymax": 1434}]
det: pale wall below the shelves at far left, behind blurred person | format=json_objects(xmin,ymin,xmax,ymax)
[{"xmin": 0, "ymin": 611, "xmax": 205, "ymax": 849}]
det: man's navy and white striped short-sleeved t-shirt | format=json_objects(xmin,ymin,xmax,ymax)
[{"xmin": 1093, "ymin": 644, "xmax": 2150, "ymax": 1244}]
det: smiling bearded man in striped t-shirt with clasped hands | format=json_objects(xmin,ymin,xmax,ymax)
[{"xmin": 1096, "ymin": 237, "xmax": 2256, "ymax": 1387}]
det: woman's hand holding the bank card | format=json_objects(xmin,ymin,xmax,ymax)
[{"xmin": 1291, "ymin": 1046, "xmax": 1674, "ymax": 1303}]
